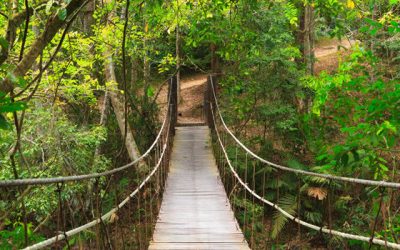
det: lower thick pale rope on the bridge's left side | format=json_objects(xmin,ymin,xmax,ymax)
[{"xmin": 24, "ymin": 108, "xmax": 171, "ymax": 250}]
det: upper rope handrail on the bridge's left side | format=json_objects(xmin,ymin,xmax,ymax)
[{"xmin": 0, "ymin": 78, "xmax": 172, "ymax": 187}]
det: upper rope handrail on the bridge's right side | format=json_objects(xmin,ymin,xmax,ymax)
[{"xmin": 210, "ymin": 77, "xmax": 400, "ymax": 189}]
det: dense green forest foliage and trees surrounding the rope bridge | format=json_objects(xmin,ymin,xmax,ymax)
[{"xmin": 0, "ymin": 0, "xmax": 400, "ymax": 248}]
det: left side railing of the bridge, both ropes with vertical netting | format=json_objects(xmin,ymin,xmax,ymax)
[{"xmin": 0, "ymin": 77, "xmax": 176, "ymax": 249}]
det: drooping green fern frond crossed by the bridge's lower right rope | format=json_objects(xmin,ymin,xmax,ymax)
[{"xmin": 271, "ymin": 194, "xmax": 297, "ymax": 239}]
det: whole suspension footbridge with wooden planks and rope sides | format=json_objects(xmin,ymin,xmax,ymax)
[{"xmin": 0, "ymin": 76, "xmax": 400, "ymax": 249}]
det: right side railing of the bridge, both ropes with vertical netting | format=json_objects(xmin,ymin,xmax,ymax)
[{"xmin": 205, "ymin": 76, "xmax": 400, "ymax": 249}]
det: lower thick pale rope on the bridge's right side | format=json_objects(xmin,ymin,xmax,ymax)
[{"xmin": 210, "ymin": 103, "xmax": 400, "ymax": 249}]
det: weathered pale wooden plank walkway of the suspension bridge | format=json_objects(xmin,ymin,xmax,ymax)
[{"xmin": 149, "ymin": 126, "xmax": 249, "ymax": 250}]
